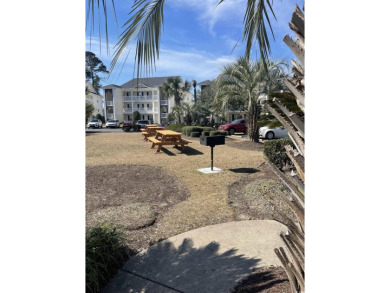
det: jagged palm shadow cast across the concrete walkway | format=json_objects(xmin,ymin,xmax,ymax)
[{"xmin": 102, "ymin": 238, "xmax": 260, "ymax": 293}]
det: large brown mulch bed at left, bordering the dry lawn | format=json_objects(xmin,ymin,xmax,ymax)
[{"xmin": 86, "ymin": 165, "xmax": 190, "ymax": 252}]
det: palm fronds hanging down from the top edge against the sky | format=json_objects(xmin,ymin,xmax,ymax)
[{"xmin": 87, "ymin": 0, "xmax": 276, "ymax": 77}]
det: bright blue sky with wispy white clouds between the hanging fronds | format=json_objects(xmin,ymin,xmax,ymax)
[{"xmin": 85, "ymin": 0, "xmax": 303, "ymax": 85}]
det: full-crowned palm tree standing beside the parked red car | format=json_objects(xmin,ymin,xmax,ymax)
[{"xmin": 214, "ymin": 57, "xmax": 287, "ymax": 142}]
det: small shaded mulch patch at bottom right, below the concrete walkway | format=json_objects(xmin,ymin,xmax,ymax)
[{"xmin": 232, "ymin": 267, "xmax": 291, "ymax": 293}]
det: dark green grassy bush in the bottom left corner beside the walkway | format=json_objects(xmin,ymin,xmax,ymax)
[{"xmin": 85, "ymin": 224, "xmax": 127, "ymax": 293}]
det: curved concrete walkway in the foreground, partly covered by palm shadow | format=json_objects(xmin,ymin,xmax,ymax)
[{"xmin": 102, "ymin": 220, "xmax": 287, "ymax": 293}]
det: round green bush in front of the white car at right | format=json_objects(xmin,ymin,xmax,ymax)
[{"xmin": 264, "ymin": 137, "xmax": 294, "ymax": 169}]
